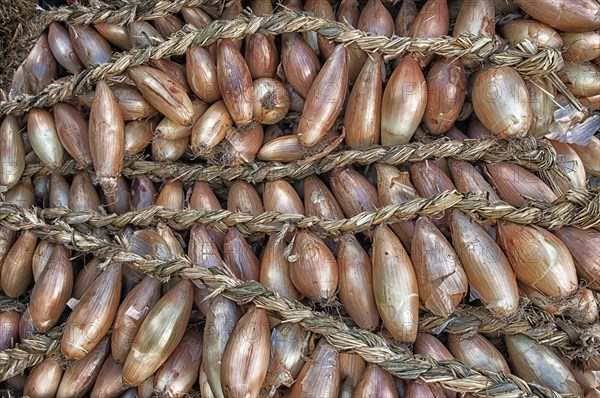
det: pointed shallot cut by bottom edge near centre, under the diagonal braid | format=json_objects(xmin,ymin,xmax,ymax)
[{"xmin": 289, "ymin": 339, "xmax": 340, "ymax": 398}]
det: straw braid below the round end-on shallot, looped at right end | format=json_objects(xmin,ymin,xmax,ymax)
[{"xmin": 23, "ymin": 137, "xmax": 556, "ymax": 183}]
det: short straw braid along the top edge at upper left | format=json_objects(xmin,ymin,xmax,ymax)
[{"xmin": 38, "ymin": 0, "xmax": 225, "ymax": 26}]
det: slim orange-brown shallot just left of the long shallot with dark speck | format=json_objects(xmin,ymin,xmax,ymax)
[{"xmin": 337, "ymin": 235, "xmax": 379, "ymax": 330}]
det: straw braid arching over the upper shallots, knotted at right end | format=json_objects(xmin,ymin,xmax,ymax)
[{"xmin": 0, "ymin": 10, "xmax": 564, "ymax": 115}]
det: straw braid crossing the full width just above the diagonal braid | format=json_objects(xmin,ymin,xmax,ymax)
[{"xmin": 0, "ymin": 190, "xmax": 600, "ymax": 235}]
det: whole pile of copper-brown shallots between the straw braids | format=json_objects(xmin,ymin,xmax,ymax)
[{"xmin": 0, "ymin": 0, "xmax": 600, "ymax": 398}]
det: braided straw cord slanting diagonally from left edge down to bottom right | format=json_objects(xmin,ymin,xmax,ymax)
[{"xmin": 0, "ymin": 208, "xmax": 596, "ymax": 397}]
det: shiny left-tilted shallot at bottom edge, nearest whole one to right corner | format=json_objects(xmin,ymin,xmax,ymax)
[{"xmin": 504, "ymin": 334, "xmax": 583, "ymax": 397}]
